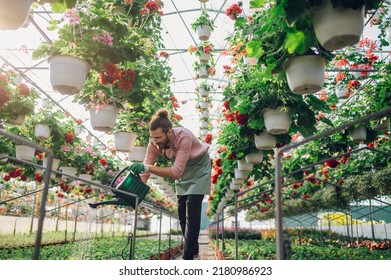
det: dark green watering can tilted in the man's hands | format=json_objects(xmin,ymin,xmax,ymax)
[{"xmin": 89, "ymin": 167, "xmax": 150, "ymax": 209}]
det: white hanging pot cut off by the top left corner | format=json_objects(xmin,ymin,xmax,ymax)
[{"xmin": 0, "ymin": 0, "xmax": 33, "ymax": 30}]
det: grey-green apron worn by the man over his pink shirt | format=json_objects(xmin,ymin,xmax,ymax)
[{"xmin": 175, "ymin": 152, "xmax": 211, "ymax": 195}]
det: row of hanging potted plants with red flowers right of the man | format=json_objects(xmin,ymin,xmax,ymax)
[{"xmin": 207, "ymin": 0, "xmax": 391, "ymax": 219}]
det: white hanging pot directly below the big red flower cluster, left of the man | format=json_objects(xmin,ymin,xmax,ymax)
[{"xmin": 90, "ymin": 105, "xmax": 118, "ymax": 131}]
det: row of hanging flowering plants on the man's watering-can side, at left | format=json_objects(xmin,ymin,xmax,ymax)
[{"xmin": 0, "ymin": 0, "xmax": 181, "ymax": 215}]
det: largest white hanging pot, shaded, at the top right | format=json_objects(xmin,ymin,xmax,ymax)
[{"xmin": 311, "ymin": 0, "xmax": 364, "ymax": 51}]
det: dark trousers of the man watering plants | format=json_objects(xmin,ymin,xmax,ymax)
[{"xmin": 177, "ymin": 194, "xmax": 204, "ymax": 260}]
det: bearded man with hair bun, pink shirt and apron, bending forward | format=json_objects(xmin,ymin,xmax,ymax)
[{"xmin": 129, "ymin": 109, "xmax": 211, "ymax": 260}]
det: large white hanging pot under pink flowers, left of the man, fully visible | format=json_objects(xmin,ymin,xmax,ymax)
[{"xmin": 49, "ymin": 55, "xmax": 91, "ymax": 95}]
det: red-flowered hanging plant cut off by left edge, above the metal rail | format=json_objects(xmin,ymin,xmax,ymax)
[{"xmin": 0, "ymin": 69, "xmax": 38, "ymax": 125}]
